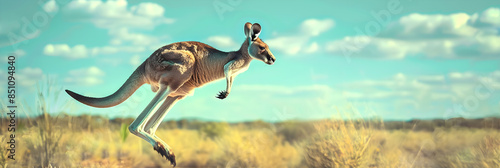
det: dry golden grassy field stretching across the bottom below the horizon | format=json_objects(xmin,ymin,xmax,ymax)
[{"xmin": 0, "ymin": 114, "xmax": 500, "ymax": 168}]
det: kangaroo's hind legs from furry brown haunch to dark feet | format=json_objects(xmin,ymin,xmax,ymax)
[{"xmin": 130, "ymin": 51, "xmax": 194, "ymax": 166}]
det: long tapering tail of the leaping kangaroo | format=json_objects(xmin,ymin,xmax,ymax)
[{"xmin": 66, "ymin": 62, "xmax": 146, "ymax": 108}]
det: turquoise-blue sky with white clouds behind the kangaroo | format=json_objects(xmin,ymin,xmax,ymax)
[{"xmin": 0, "ymin": 0, "xmax": 500, "ymax": 121}]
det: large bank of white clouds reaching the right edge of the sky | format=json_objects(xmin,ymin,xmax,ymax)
[{"xmin": 325, "ymin": 8, "xmax": 500, "ymax": 59}]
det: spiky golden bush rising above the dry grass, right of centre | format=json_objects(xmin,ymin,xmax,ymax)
[{"xmin": 304, "ymin": 121, "xmax": 372, "ymax": 167}]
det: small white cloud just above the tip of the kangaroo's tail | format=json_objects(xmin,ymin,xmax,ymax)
[{"xmin": 64, "ymin": 66, "xmax": 105, "ymax": 86}]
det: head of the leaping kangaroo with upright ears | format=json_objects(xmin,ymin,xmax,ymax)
[{"xmin": 245, "ymin": 22, "xmax": 276, "ymax": 65}]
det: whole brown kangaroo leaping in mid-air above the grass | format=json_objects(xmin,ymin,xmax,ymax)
[{"xmin": 66, "ymin": 22, "xmax": 276, "ymax": 167}]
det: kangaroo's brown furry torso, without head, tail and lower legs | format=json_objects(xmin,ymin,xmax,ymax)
[{"xmin": 144, "ymin": 41, "xmax": 252, "ymax": 96}]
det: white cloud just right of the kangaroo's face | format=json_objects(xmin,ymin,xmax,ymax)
[{"xmin": 266, "ymin": 19, "xmax": 334, "ymax": 55}]
